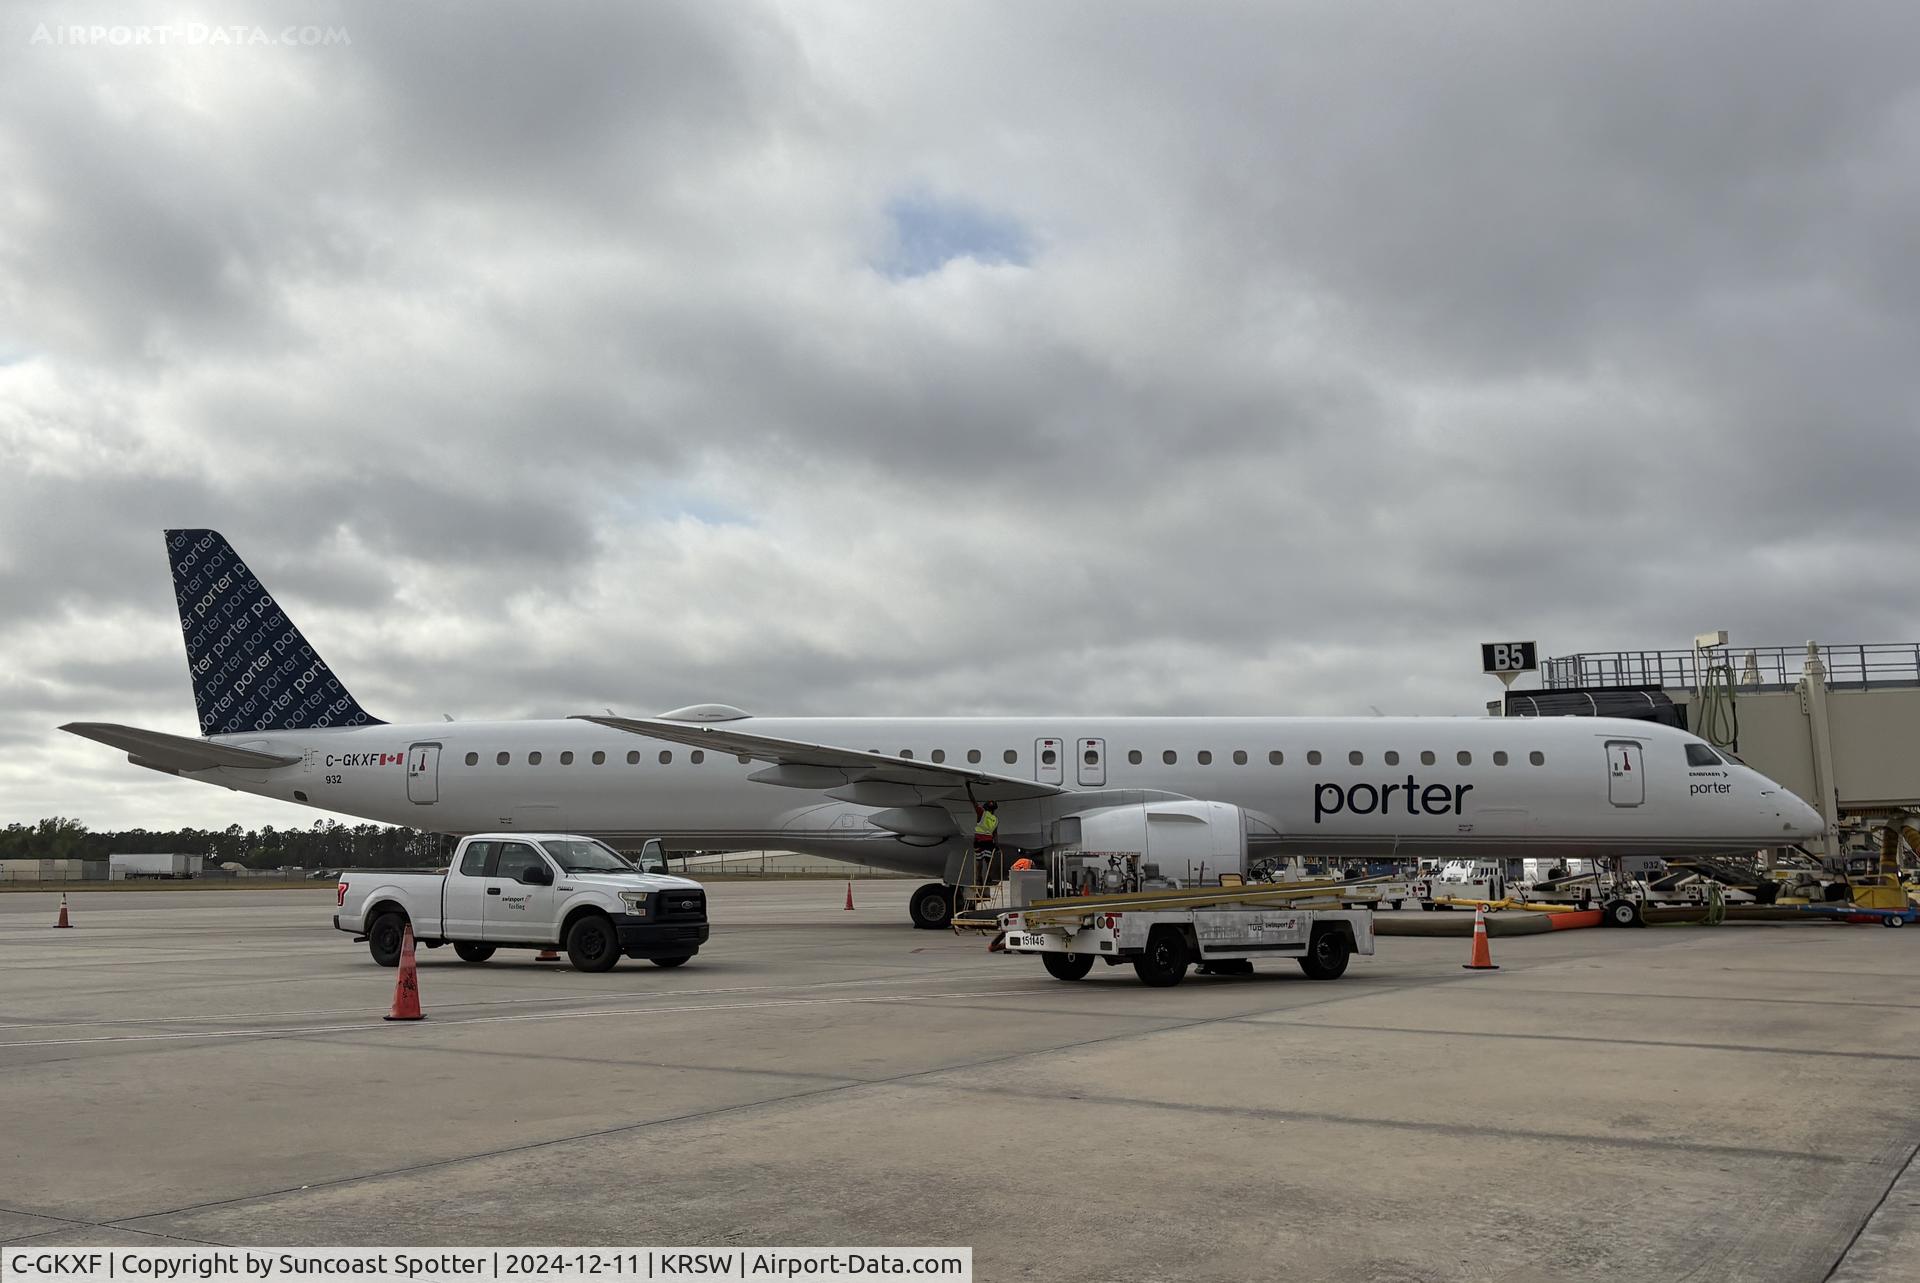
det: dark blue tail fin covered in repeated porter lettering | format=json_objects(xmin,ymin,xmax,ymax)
[{"xmin": 167, "ymin": 530, "xmax": 380, "ymax": 736}]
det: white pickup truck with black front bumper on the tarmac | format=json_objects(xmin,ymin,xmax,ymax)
[{"xmin": 334, "ymin": 834, "xmax": 707, "ymax": 972}]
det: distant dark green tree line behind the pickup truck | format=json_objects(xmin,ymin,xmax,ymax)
[{"xmin": 0, "ymin": 816, "xmax": 453, "ymax": 868}]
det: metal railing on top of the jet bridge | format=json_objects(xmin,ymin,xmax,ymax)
[{"xmin": 1540, "ymin": 642, "xmax": 1920, "ymax": 690}]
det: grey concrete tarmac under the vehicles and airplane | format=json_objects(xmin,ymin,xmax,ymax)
[{"xmin": 0, "ymin": 882, "xmax": 1920, "ymax": 1283}]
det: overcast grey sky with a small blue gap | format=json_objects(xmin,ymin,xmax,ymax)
[{"xmin": 0, "ymin": 0, "xmax": 1920, "ymax": 828}]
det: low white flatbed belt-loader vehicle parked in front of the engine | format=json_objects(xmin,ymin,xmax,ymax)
[{"xmin": 998, "ymin": 887, "xmax": 1373, "ymax": 987}]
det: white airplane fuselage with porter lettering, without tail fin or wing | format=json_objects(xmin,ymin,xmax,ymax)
[{"xmin": 190, "ymin": 716, "xmax": 1820, "ymax": 874}]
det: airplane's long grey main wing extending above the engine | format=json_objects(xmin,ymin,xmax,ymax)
[{"xmin": 578, "ymin": 714, "xmax": 1066, "ymax": 805}]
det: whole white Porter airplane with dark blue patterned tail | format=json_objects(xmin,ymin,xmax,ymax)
[{"xmin": 63, "ymin": 530, "xmax": 1822, "ymax": 928}]
